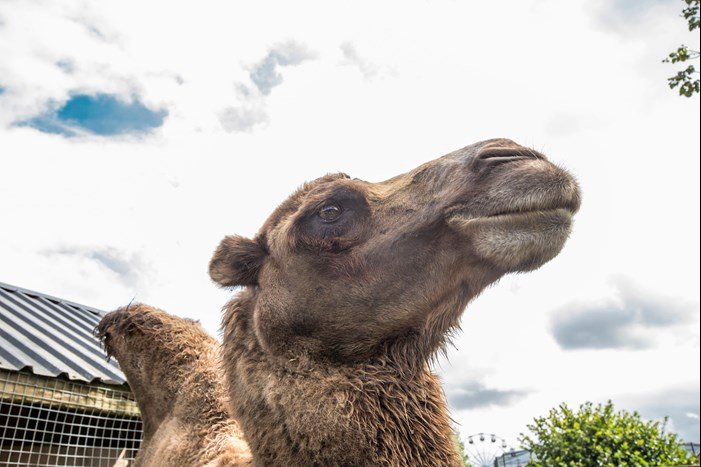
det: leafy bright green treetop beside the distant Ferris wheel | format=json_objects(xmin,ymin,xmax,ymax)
[{"xmin": 520, "ymin": 401, "xmax": 698, "ymax": 467}]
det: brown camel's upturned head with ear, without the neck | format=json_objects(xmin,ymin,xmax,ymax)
[{"xmin": 209, "ymin": 139, "xmax": 580, "ymax": 364}]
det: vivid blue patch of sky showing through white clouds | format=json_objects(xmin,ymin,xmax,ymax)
[{"xmin": 20, "ymin": 94, "xmax": 168, "ymax": 136}]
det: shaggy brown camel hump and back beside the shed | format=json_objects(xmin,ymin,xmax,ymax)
[{"xmin": 96, "ymin": 305, "xmax": 251, "ymax": 467}]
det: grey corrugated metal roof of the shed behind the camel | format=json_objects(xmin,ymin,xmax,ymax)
[{"xmin": 0, "ymin": 282, "xmax": 126, "ymax": 385}]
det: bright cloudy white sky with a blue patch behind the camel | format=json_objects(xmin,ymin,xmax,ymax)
[{"xmin": 0, "ymin": 0, "xmax": 701, "ymax": 456}]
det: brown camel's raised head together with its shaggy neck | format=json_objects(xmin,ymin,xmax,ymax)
[{"xmin": 210, "ymin": 140, "xmax": 580, "ymax": 466}]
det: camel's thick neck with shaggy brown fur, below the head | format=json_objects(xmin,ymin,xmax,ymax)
[{"xmin": 223, "ymin": 298, "xmax": 460, "ymax": 466}]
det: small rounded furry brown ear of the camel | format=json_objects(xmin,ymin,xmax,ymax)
[{"xmin": 209, "ymin": 235, "xmax": 266, "ymax": 287}]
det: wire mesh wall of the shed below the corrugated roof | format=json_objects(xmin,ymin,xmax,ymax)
[{"xmin": 0, "ymin": 369, "xmax": 142, "ymax": 467}]
